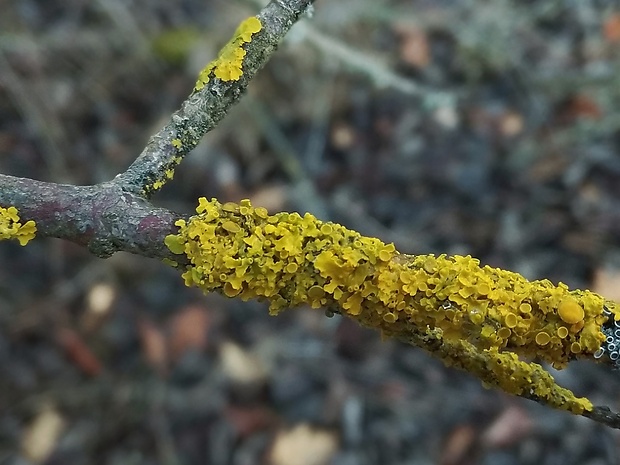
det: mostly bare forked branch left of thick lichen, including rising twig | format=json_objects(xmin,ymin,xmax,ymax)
[{"xmin": 0, "ymin": 0, "xmax": 313, "ymax": 254}]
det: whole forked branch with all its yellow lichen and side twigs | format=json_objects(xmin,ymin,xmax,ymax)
[{"xmin": 0, "ymin": 0, "xmax": 620, "ymax": 428}]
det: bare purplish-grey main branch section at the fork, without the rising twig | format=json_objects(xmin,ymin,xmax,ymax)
[{"xmin": 0, "ymin": 174, "xmax": 179, "ymax": 261}]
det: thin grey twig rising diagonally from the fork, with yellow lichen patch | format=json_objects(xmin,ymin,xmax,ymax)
[{"xmin": 117, "ymin": 0, "xmax": 313, "ymax": 197}]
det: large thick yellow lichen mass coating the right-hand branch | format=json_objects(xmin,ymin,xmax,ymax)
[{"xmin": 166, "ymin": 198, "xmax": 618, "ymax": 412}]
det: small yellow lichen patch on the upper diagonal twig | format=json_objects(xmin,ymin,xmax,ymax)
[{"xmin": 194, "ymin": 16, "xmax": 262, "ymax": 90}]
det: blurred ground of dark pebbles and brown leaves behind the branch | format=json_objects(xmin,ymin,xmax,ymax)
[{"xmin": 0, "ymin": 0, "xmax": 620, "ymax": 465}]
